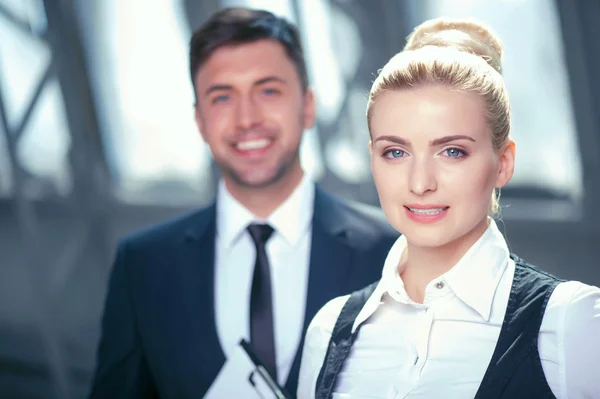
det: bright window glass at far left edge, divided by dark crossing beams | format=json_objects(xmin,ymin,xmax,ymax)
[{"xmin": 0, "ymin": 1, "xmax": 71, "ymax": 195}]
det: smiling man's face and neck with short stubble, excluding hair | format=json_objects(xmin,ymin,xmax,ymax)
[{"xmin": 192, "ymin": 39, "xmax": 315, "ymax": 217}]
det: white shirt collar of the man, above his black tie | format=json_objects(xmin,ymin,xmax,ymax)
[{"xmin": 217, "ymin": 174, "xmax": 315, "ymax": 248}]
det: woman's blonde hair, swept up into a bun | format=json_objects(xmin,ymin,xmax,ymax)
[{"xmin": 367, "ymin": 18, "xmax": 510, "ymax": 215}]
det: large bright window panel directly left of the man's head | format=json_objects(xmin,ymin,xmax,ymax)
[{"xmin": 78, "ymin": 0, "xmax": 211, "ymax": 203}]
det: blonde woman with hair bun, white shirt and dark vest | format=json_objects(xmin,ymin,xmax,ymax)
[{"xmin": 298, "ymin": 19, "xmax": 600, "ymax": 399}]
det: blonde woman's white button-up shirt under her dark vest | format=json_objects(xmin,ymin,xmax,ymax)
[{"xmin": 298, "ymin": 221, "xmax": 600, "ymax": 399}]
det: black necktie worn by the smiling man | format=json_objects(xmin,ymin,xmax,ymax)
[{"xmin": 248, "ymin": 224, "xmax": 277, "ymax": 381}]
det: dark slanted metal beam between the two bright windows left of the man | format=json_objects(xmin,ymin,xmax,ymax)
[{"xmin": 44, "ymin": 0, "xmax": 113, "ymax": 266}]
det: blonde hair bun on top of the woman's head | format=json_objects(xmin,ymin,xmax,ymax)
[{"xmin": 404, "ymin": 17, "xmax": 503, "ymax": 74}]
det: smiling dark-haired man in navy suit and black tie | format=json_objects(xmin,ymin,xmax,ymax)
[{"xmin": 91, "ymin": 8, "xmax": 398, "ymax": 398}]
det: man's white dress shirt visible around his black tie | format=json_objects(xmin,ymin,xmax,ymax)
[{"xmin": 215, "ymin": 175, "xmax": 315, "ymax": 385}]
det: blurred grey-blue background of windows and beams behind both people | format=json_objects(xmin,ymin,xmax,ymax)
[{"xmin": 0, "ymin": 0, "xmax": 600, "ymax": 399}]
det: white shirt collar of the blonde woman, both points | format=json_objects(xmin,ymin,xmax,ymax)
[{"xmin": 352, "ymin": 218, "xmax": 510, "ymax": 332}]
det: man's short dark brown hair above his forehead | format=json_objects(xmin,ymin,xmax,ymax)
[{"xmin": 190, "ymin": 8, "xmax": 308, "ymax": 100}]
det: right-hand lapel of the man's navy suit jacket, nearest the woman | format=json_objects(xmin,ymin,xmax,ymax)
[{"xmin": 286, "ymin": 186, "xmax": 353, "ymax": 395}]
